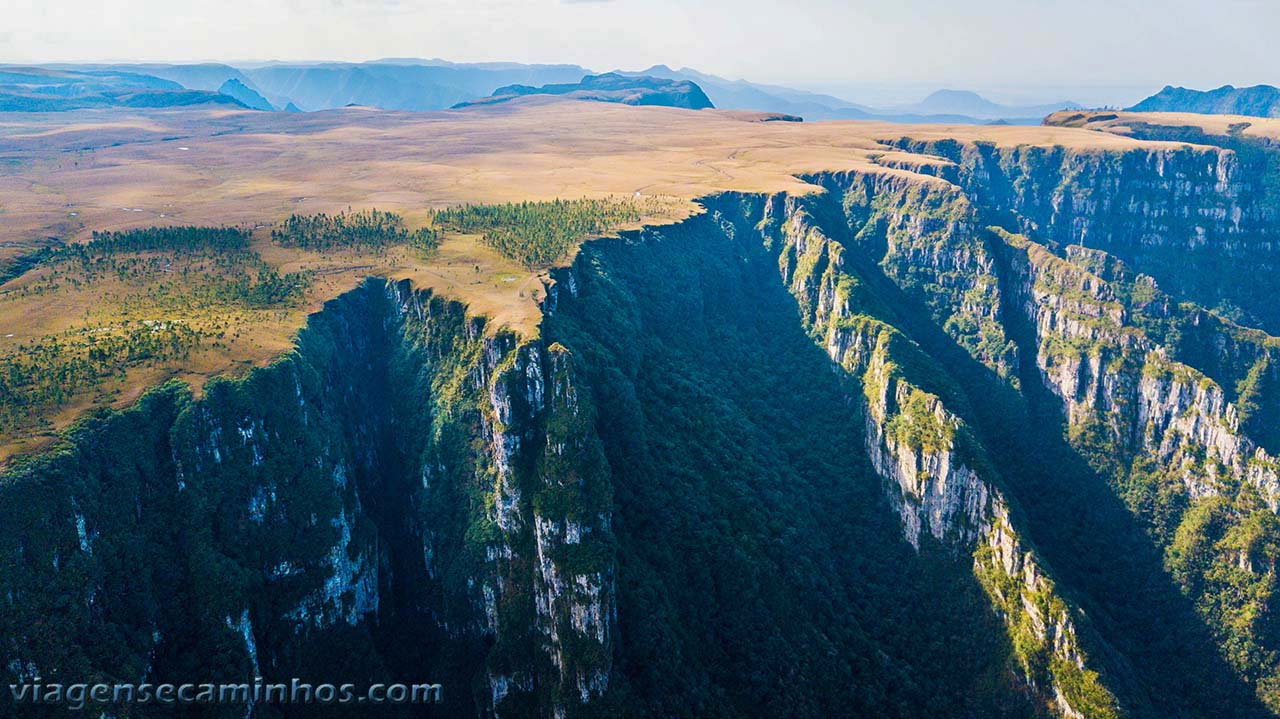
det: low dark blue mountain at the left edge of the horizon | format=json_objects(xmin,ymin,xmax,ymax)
[{"xmin": 0, "ymin": 68, "xmax": 244, "ymax": 113}]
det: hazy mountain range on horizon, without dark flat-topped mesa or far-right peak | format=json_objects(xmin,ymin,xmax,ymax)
[{"xmin": 0, "ymin": 58, "xmax": 1079, "ymax": 124}]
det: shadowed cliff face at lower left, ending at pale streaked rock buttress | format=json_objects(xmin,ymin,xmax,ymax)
[{"xmin": 0, "ymin": 280, "xmax": 613, "ymax": 715}]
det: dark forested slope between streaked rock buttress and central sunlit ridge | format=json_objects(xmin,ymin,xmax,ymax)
[{"xmin": 545, "ymin": 221, "xmax": 1033, "ymax": 716}]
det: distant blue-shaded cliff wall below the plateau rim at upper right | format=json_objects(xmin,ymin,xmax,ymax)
[{"xmin": 895, "ymin": 133, "xmax": 1280, "ymax": 331}]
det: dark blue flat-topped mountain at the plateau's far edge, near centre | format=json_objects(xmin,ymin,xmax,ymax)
[{"xmin": 454, "ymin": 73, "xmax": 716, "ymax": 110}]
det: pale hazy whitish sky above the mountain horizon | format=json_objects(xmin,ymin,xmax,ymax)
[{"xmin": 0, "ymin": 0, "xmax": 1280, "ymax": 101}]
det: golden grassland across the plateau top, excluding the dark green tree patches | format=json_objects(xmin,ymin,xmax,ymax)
[{"xmin": 0, "ymin": 99, "xmax": 1208, "ymax": 461}]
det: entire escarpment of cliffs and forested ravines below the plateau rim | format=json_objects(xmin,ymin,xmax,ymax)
[{"xmin": 0, "ymin": 129, "xmax": 1280, "ymax": 718}]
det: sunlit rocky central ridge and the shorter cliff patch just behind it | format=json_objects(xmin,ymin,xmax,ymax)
[{"xmin": 760, "ymin": 191, "xmax": 1116, "ymax": 716}]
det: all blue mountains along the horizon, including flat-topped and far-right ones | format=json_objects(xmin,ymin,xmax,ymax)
[{"xmin": 12, "ymin": 58, "xmax": 1280, "ymax": 124}]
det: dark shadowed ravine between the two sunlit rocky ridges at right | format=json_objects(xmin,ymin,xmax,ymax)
[{"xmin": 778, "ymin": 193, "xmax": 1271, "ymax": 718}]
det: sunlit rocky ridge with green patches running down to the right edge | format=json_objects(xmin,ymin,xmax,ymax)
[{"xmin": 995, "ymin": 232, "xmax": 1280, "ymax": 702}]
